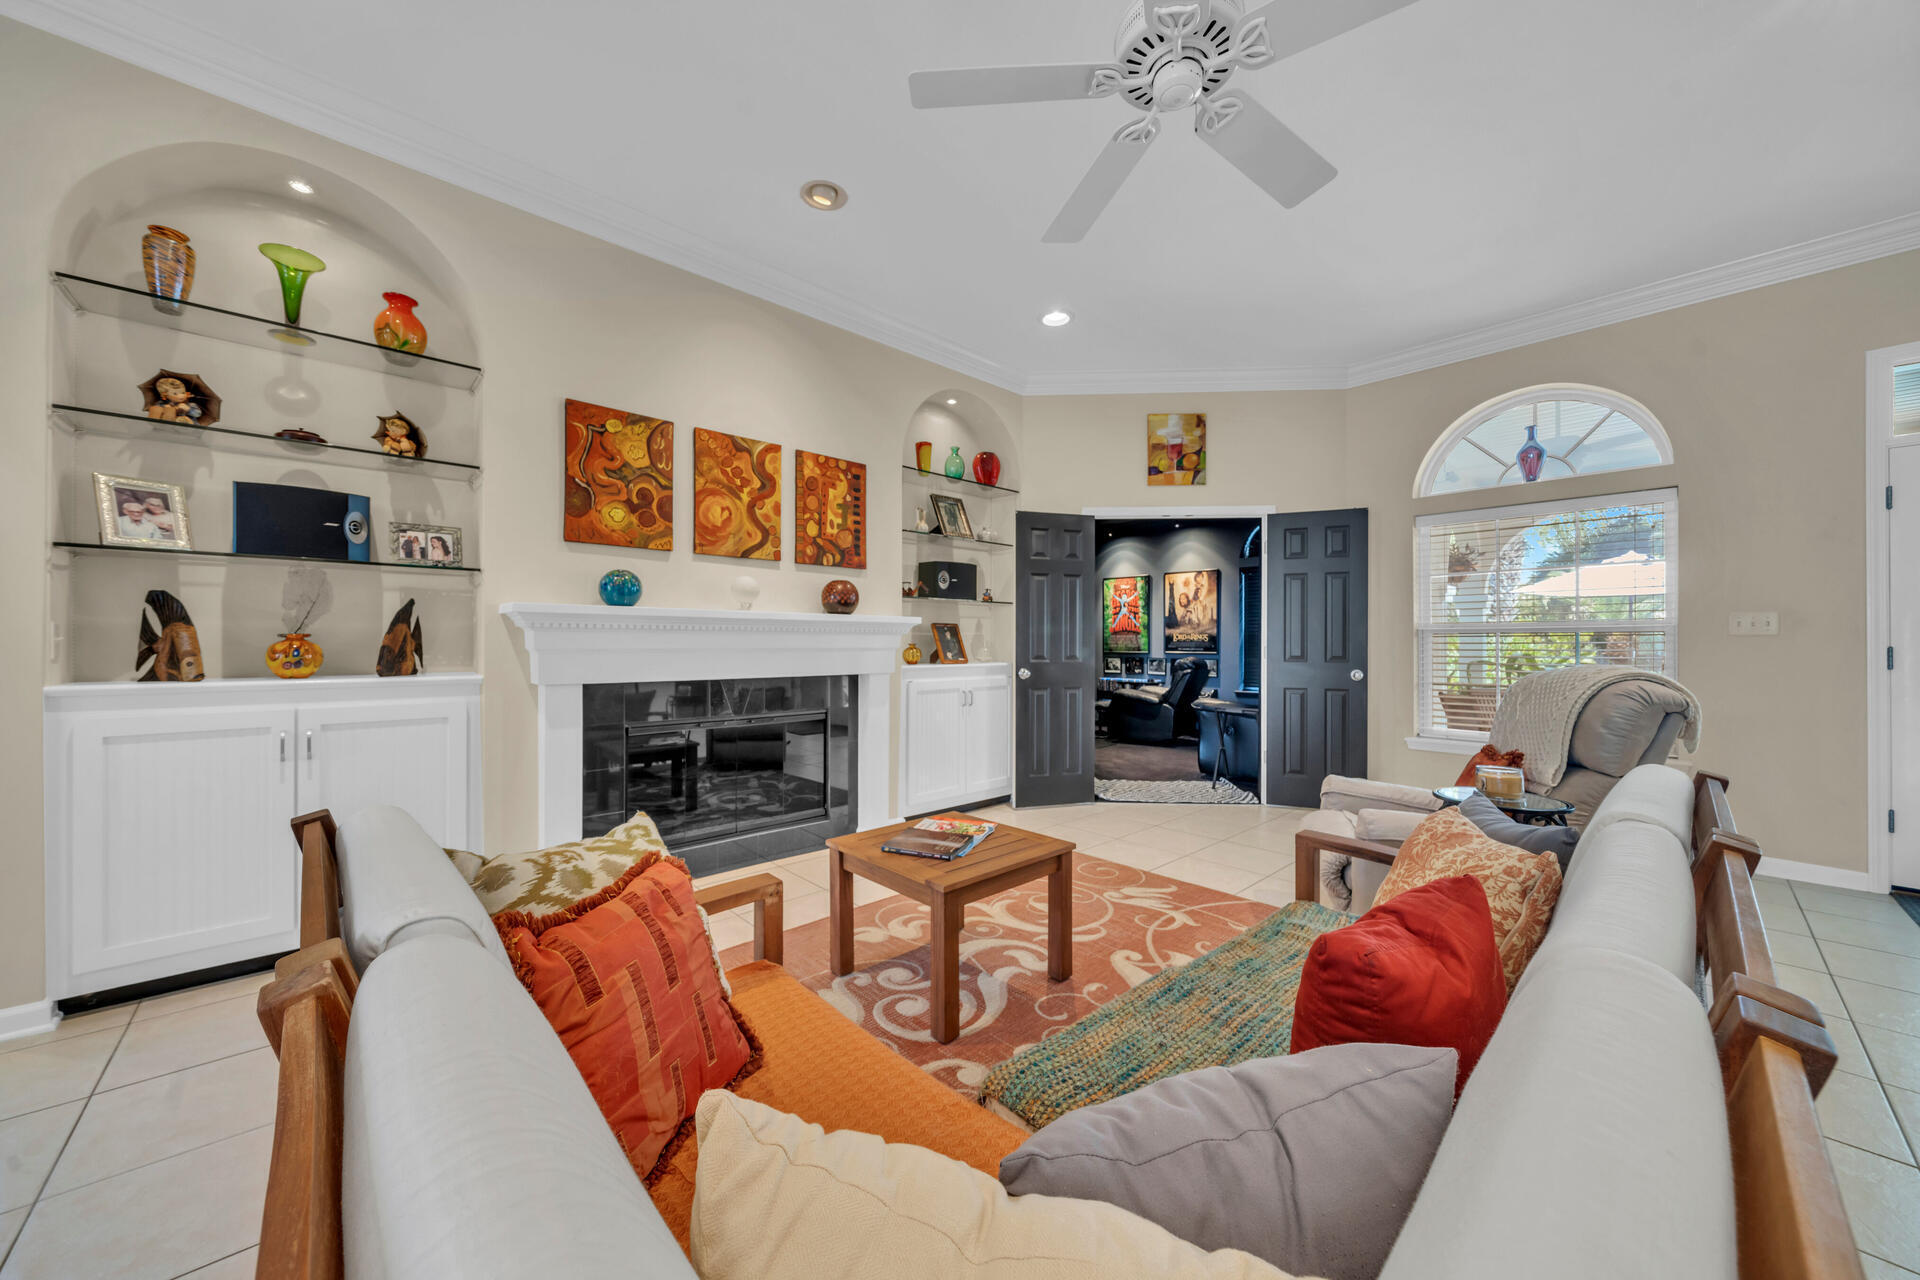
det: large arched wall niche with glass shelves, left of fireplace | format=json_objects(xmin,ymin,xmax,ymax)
[{"xmin": 46, "ymin": 142, "xmax": 484, "ymax": 683}]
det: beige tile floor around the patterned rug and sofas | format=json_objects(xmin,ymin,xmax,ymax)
[{"xmin": 0, "ymin": 804, "xmax": 1920, "ymax": 1280}]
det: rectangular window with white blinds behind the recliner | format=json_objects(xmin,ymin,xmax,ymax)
[{"xmin": 1413, "ymin": 489, "xmax": 1680, "ymax": 743}]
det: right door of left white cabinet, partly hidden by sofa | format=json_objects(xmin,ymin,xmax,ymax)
[{"xmin": 300, "ymin": 699, "xmax": 472, "ymax": 848}]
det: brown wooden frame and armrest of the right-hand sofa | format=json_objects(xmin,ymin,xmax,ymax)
[{"xmin": 1294, "ymin": 773, "xmax": 1864, "ymax": 1280}]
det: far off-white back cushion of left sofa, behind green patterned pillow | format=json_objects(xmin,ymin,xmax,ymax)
[{"xmin": 336, "ymin": 804, "xmax": 507, "ymax": 973}]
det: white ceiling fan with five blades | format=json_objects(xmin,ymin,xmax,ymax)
[{"xmin": 906, "ymin": 0, "xmax": 1413, "ymax": 244}]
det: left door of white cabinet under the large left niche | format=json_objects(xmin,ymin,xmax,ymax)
[{"xmin": 65, "ymin": 708, "xmax": 300, "ymax": 992}]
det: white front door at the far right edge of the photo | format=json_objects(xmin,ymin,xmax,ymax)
[{"xmin": 1887, "ymin": 445, "xmax": 1920, "ymax": 889}]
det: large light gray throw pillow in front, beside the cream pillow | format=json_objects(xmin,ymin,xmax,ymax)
[{"xmin": 1000, "ymin": 1044, "xmax": 1457, "ymax": 1280}]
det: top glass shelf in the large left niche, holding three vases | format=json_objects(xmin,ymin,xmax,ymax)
[{"xmin": 54, "ymin": 271, "xmax": 480, "ymax": 391}]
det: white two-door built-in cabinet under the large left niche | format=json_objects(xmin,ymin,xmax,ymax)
[{"xmin": 44, "ymin": 674, "xmax": 480, "ymax": 1000}]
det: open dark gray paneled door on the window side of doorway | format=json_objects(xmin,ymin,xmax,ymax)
[{"xmin": 1261, "ymin": 510, "xmax": 1367, "ymax": 808}]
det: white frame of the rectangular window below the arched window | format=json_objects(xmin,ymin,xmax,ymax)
[{"xmin": 1407, "ymin": 486, "xmax": 1680, "ymax": 756}]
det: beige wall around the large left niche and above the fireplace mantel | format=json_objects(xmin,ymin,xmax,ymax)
[{"xmin": 0, "ymin": 21, "xmax": 1020, "ymax": 1009}]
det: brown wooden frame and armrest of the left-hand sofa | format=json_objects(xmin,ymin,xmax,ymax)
[{"xmin": 253, "ymin": 810, "xmax": 785, "ymax": 1280}]
